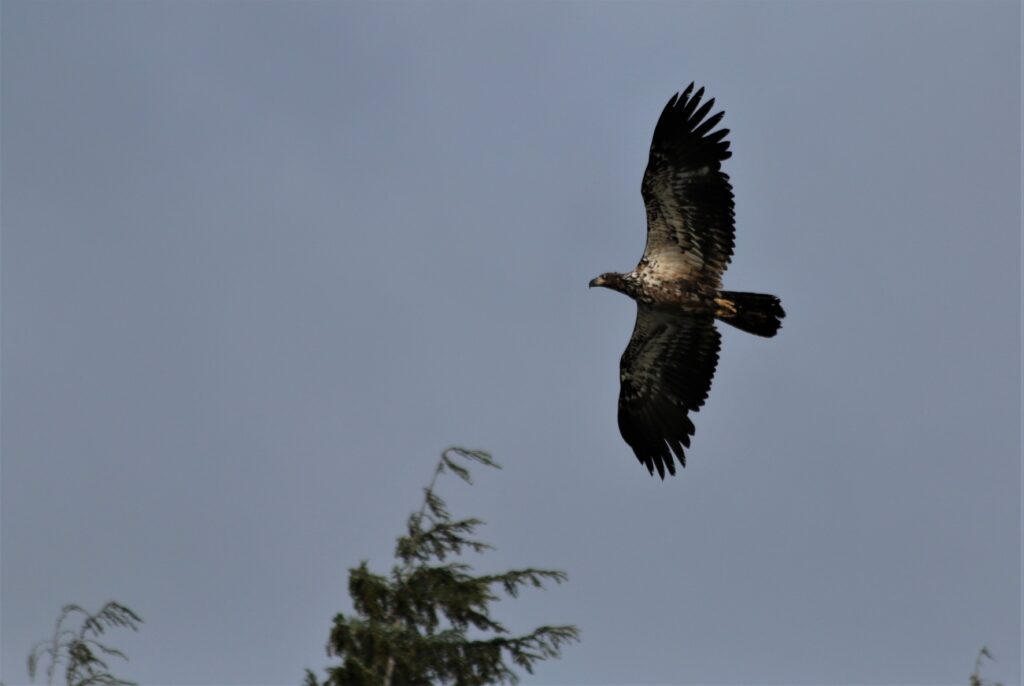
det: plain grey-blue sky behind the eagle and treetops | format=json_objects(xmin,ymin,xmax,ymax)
[{"xmin": 0, "ymin": 0, "xmax": 1021, "ymax": 686}]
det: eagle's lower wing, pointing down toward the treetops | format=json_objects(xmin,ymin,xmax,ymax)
[{"xmin": 618, "ymin": 302, "xmax": 721, "ymax": 479}]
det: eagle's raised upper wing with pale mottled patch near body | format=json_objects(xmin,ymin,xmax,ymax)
[{"xmin": 641, "ymin": 83, "xmax": 735, "ymax": 290}]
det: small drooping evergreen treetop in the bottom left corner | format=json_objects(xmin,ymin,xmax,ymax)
[{"xmin": 29, "ymin": 601, "xmax": 142, "ymax": 686}]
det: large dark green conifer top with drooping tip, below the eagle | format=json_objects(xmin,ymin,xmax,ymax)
[{"xmin": 303, "ymin": 447, "xmax": 580, "ymax": 686}]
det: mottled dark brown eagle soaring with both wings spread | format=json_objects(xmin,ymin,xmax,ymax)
[{"xmin": 590, "ymin": 83, "xmax": 785, "ymax": 479}]
